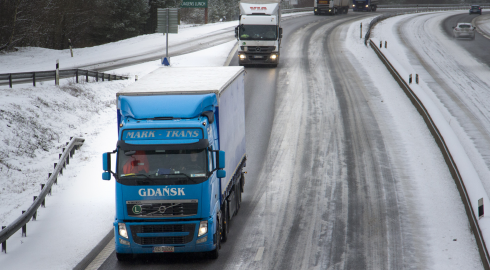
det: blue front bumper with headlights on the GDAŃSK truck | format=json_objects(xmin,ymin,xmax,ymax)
[{"xmin": 114, "ymin": 219, "xmax": 216, "ymax": 254}]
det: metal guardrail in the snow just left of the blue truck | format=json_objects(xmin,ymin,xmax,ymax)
[{"xmin": 0, "ymin": 137, "xmax": 85, "ymax": 253}]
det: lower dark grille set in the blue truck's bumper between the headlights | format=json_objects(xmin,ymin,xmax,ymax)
[{"xmin": 130, "ymin": 224, "xmax": 196, "ymax": 245}]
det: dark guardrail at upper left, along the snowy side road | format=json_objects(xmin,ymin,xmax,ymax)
[{"xmin": 0, "ymin": 69, "xmax": 128, "ymax": 88}]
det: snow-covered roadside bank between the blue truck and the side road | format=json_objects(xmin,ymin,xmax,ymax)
[{"xmin": 0, "ymin": 38, "xmax": 236, "ymax": 270}]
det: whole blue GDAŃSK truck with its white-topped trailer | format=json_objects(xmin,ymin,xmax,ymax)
[{"xmin": 102, "ymin": 67, "xmax": 246, "ymax": 260}]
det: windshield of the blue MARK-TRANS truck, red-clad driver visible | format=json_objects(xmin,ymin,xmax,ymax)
[{"xmin": 117, "ymin": 149, "xmax": 208, "ymax": 185}]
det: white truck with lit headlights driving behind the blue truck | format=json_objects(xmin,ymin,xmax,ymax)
[{"xmin": 235, "ymin": 0, "xmax": 282, "ymax": 67}]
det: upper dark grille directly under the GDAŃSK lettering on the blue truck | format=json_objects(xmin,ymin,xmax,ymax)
[{"xmin": 126, "ymin": 200, "xmax": 198, "ymax": 218}]
